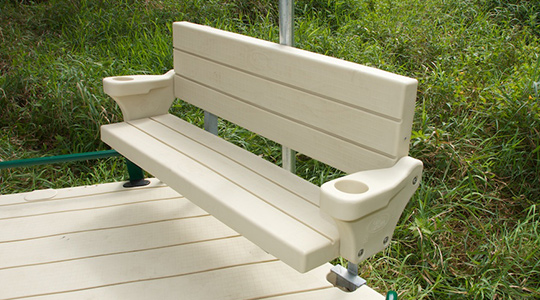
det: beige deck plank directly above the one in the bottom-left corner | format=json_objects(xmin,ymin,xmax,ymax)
[{"xmin": 0, "ymin": 216, "xmax": 238, "ymax": 270}]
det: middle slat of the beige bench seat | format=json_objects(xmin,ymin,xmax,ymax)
[{"xmin": 129, "ymin": 119, "xmax": 339, "ymax": 243}]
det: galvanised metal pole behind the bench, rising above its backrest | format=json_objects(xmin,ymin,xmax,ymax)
[{"xmin": 279, "ymin": 0, "xmax": 296, "ymax": 173}]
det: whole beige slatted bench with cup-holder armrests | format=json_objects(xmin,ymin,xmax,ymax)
[{"xmin": 101, "ymin": 22, "xmax": 422, "ymax": 272}]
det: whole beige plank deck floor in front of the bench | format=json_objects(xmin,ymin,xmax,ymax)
[{"xmin": 0, "ymin": 179, "xmax": 384, "ymax": 300}]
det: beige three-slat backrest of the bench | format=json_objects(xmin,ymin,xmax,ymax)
[{"xmin": 173, "ymin": 22, "xmax": 417, "ymax": 173}]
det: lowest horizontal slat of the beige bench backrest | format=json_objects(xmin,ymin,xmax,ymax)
[{"xmin": 174, "ymin": 76, "xmax": 393, "ymax": 172}]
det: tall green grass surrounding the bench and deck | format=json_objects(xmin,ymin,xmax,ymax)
[{"xmin": 0, "ymin": 0, "xmax": 540, "ymax": 299}]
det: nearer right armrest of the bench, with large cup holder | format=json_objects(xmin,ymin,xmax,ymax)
[{"xmin": 320, "ymin": 157, "xmax": 422, "ymax": 263}]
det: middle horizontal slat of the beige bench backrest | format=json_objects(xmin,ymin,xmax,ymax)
[{"xmin": 174, "ymin": 50, "xmax": 404, "ymax": 157}]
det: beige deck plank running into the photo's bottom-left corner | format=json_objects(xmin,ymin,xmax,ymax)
[{"xmin": 0, "ymin": 237, "xmax": 276, "ymax": 299}]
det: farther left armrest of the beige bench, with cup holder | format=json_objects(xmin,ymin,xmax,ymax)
[{"xmin": 103, "ymin": 70, "xmax": 175, "ymax": 121}]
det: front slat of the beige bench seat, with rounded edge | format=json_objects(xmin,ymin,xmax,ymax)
[{"xmin": 101, "ymin": 123, "xmax": 338, "ymax": 271}]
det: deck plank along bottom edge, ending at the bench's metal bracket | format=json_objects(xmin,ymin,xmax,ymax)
[{"xmin": 10, "ymin": 261, "xmax": 334, "ymax": 300}]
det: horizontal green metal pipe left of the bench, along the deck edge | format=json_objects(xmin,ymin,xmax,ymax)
[{"xmin": 0, "ymin": 150, "xmax": 121, "ymax": 169}]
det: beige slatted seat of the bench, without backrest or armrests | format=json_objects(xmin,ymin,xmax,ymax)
[{"xmin": 101, "ymin": 114, "xmax": 339, "ymax": 270}]
